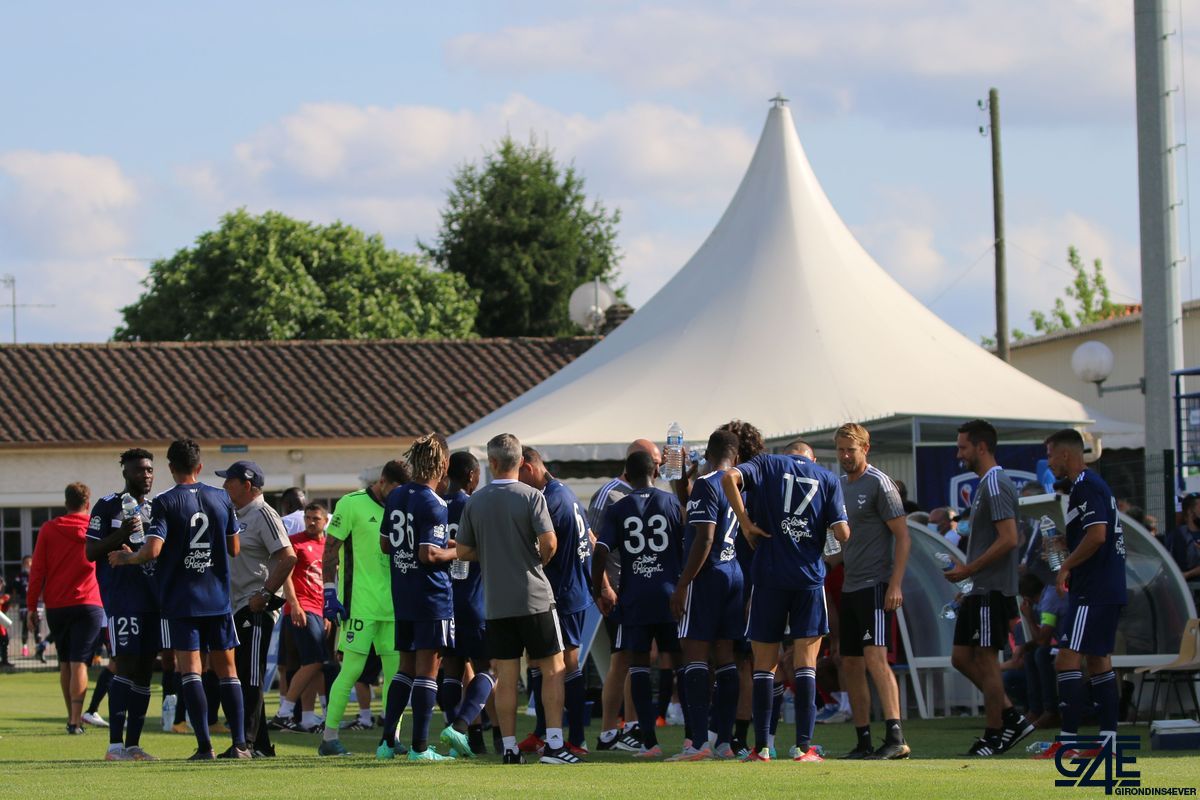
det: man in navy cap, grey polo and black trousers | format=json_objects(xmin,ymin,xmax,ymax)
[{"xmin": 217, "ymin": 461, "xmax": 296, "ymax": 756}]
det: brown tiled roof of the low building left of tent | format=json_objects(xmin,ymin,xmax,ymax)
[{"xmin": 0, "ymin": 338, "xmax": 595, "ymax": 447}]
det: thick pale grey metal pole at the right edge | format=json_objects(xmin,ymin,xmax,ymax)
[{"xmin": 1133, "ymin": 0, "xmax": 1183, "ymax": 521}]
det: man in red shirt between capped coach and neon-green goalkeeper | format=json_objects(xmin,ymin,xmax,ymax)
[{"xmin": 268, "ymin": 503, "xmax": 329, "ymax": 733}]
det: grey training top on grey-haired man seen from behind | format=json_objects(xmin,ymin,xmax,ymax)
[{"xmin": 455, "ymin": 480, "xmax": 554, "ymax": 619}]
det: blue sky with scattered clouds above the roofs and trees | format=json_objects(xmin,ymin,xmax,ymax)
[{"xmin": 0, "ymin": 0, "xmax": 1200, "ymax": 342}]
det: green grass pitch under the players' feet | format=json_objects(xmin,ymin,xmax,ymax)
[{"xmin": 0, "ymin": 673, "xmax": 1200, "ymax": 800}]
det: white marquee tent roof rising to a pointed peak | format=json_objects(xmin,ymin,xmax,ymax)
[{"xmin": 450, "ymin": 101, "xmax": 1093, "ymax": 459}]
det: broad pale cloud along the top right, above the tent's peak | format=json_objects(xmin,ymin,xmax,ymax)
[{"xmin": 445, "ymin": 0, "xmax": 1156, "ymax": 122}]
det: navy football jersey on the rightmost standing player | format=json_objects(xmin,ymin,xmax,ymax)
[{"xmin": 1067, "ymin": 469, "xmax": 1126, "ymax": 604}]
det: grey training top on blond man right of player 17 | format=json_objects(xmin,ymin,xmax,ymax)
[{"xmin": 841, "ymin": 464, "xmax": 905, "ymax": 591}]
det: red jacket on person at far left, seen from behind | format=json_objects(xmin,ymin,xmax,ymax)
[{"xmin": 25, "ymin": 511, "xmax": 101, "ymax": 608}]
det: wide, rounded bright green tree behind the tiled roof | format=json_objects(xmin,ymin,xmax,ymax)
[{"xmin": 113, "ymin": 209, "xmax": 478, "ymax": 342}]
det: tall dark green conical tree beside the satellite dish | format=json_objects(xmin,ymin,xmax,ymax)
[{"xmin": 421, "ymin": 137, "xmax": 620, "ymax": 336}]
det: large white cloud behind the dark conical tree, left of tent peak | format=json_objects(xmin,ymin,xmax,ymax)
[{"xmin": 175, "ymin": 95, "xmax": 754, "ymax": 302}]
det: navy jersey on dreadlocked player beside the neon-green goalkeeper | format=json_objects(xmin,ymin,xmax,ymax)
[{"xmin": 379, "ymin": 483, "xmax": 454, "ymax": 622}]
